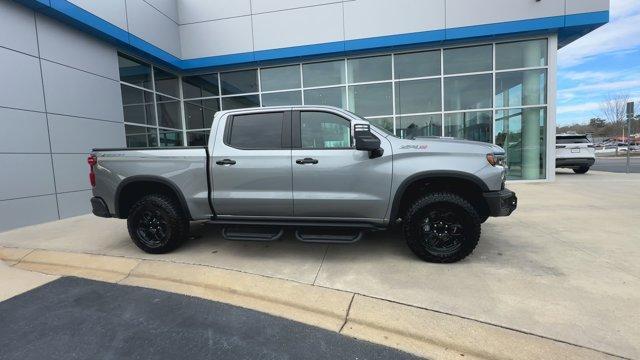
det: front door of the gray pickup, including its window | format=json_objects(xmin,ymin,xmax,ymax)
[{"xmin": 291, "ymin": 110, "xmax": 392, "ymax": 220}]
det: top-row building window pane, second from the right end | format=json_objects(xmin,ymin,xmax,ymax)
[{"xmin": 444, "ymin": 45, "xmax": 493, "ymax": 74}]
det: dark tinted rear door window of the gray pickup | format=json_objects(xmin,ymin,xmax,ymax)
[{"xmin": 229, "ymin": 113, "xmax": 284, "ymax": 149}]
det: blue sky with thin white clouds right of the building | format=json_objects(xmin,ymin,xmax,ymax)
[{"xmin": 556, "ymin": 0, "xmax": 640, "ymax": 126}]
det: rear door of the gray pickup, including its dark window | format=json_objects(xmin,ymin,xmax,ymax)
[{"xmin": 211, "ymin": 110, "xmax": 293, "ymax": 217}]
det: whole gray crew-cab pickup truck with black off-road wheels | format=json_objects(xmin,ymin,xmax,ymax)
[{"xmin": 88, "ymin": 106, "xmax": 517, "ymax": 263}]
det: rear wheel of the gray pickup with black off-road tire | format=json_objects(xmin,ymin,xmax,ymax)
[{"xmin": 127, "ymin": 194, "xmax": 189, "ymax": 254}]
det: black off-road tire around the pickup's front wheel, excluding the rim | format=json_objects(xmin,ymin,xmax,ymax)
[{"xmin": 403, "ymin": 192, "xmax": 481, "ymax": 263}]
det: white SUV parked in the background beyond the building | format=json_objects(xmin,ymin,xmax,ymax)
[{"xmin": 556, "ymin": 134, "xmax": 596, "ymax": 174}]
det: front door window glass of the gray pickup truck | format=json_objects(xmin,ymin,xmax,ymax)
[{"xmin": 300, "ymin": 111, "xmax": 351, "ymax": 149}]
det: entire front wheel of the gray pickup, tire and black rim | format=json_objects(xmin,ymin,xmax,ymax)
[{"xmin": 404, "ymin": 192, "xmax": 481, "ymax": 263}]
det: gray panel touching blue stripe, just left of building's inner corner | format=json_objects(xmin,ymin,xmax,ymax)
[{"xmin": 127, "ymin": 0, "xmax": 180, "ymax": 57}]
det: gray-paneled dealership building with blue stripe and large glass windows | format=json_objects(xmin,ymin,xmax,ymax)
[{"xmin": 0, "ymin": 0, "xmax": 609, "ymax": 231}]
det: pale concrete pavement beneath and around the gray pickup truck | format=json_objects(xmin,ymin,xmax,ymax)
[{"xmin": 0, "ymin": 172, "xmax": 640, "ymax": 358}]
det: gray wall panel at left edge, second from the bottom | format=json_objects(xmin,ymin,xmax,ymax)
[{"xmin": 0, "ymin": 154, "xmax": 55, "ymax": 200}]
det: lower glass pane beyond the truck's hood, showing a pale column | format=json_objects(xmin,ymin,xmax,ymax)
[{"xmin": 495, "ymin": 108, "xmax": 547, "ymax": 180}]
